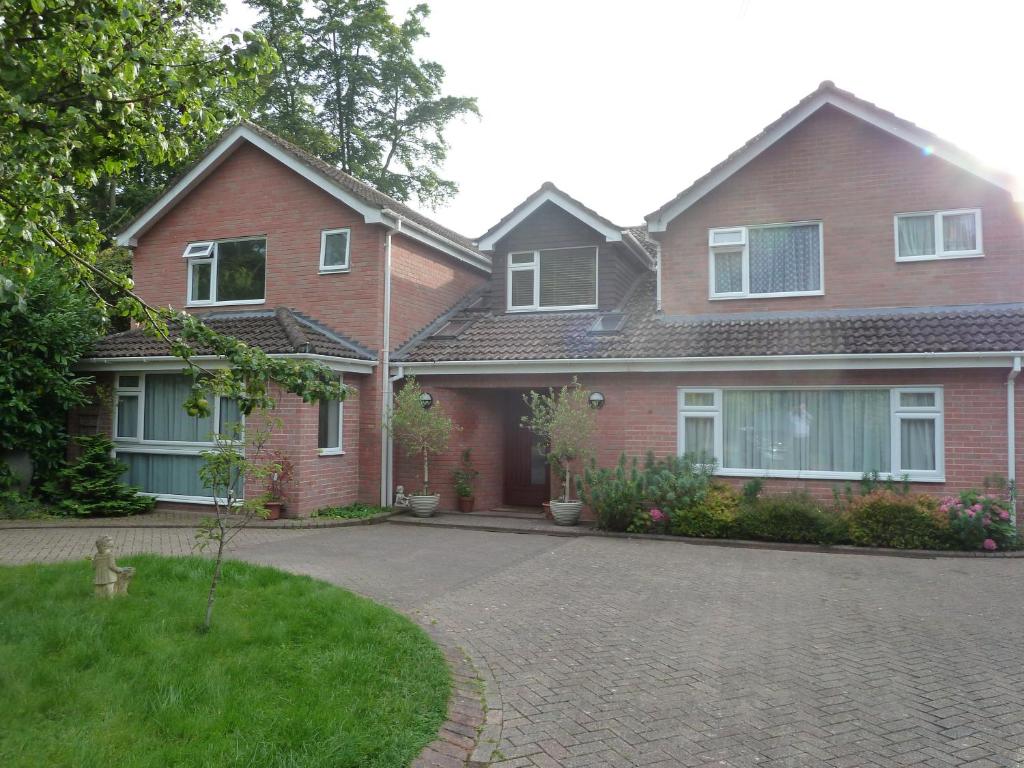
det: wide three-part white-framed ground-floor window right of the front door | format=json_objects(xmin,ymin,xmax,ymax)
[{"xmin": 678, "ymin": 386, "xmax": 944, "ymax": 481}]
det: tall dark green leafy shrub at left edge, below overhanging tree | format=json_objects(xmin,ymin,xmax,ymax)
[{"xmin": 0, "ymin": 257, "xmax": 103, "ymax": 473}]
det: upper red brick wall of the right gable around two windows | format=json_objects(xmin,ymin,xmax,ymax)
[{"xmin": 659, "ymin": 108, "xmax": 1024, "ymax": 314}]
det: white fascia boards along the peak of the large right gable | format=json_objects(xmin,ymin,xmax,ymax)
[{"xmin": 647, "ymin": 93, "xmax": 1019, "ymax": 232}]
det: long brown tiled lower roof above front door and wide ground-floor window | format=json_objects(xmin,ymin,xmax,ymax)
[{"xmin": 392, "ymin": 273, "xmax": 1024, "ymax": 364}]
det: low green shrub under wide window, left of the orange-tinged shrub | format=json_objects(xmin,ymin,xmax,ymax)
[{"xmin": 737, "ymin": 492, "xmax": 846, "ymax": 544}]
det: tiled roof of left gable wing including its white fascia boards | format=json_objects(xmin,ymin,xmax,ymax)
[{"xmin": 117, "ymin": 121, "xmax": 490, "ymax": 271}]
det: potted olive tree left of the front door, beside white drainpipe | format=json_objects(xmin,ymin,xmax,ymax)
[{"xmin": 387, "ymin": 377, "xmax": 456, "ymax": 517}]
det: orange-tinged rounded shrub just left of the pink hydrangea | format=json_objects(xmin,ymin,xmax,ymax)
[{"xmin": 847, "ymin": 490, "xmax": 948, "ymax": 549}]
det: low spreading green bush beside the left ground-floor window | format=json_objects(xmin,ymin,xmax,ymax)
[{"xmin": 45, "ymin": 435, "xmax": 156, "ymax": 517}]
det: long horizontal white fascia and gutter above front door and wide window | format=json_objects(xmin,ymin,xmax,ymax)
[{"xmin": 393, "ymin": 351, "xmax": 1021, "ymax": 376}]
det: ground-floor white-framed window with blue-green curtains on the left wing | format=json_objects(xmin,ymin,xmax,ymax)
[{"xmin": 114, "ymin": 373, "xmax": 245, "ymax": 503}]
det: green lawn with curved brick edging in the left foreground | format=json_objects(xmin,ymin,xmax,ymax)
[{"xmin": 0, "ymin": 556, "xmax": 451, "ymax": 768}]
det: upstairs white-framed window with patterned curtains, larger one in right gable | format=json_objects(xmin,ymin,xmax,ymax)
[{"xmin": 708, "ymin": 221, "xmax": 824, "ymax": 299}]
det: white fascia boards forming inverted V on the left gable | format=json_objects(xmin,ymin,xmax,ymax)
[{"xmin": 116, "ymin": 125, "xmax": 383, "ymax": 247}]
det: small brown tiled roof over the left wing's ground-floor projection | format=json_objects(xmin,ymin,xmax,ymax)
[{"xmin": 83, "ymin": 307, "xmax": 377, "ymax": 364}]
